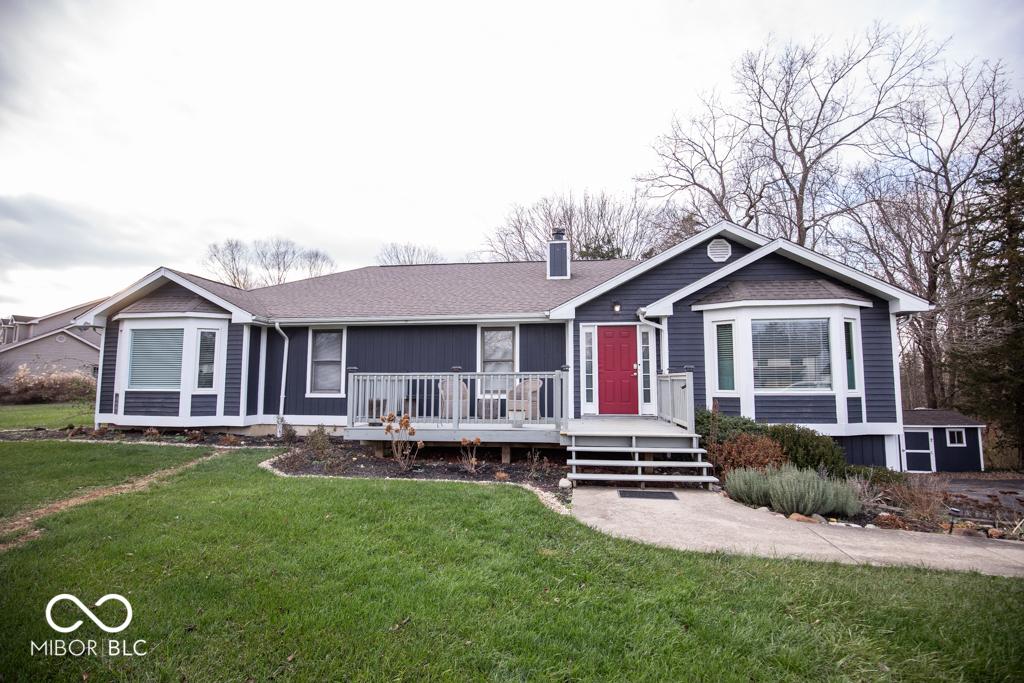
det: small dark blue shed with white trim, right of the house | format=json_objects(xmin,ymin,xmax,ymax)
[{"xmin": 901, "ymin": 408, "xmax": 985, "ymax": 472}]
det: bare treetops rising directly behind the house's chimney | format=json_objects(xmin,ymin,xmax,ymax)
[{"xmin": 486, "ymin": 193, "xmax": 695, "ymax": 261}]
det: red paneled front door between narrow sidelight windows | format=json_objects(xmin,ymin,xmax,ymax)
[{"xmin": 597, "ymin": 326, "xmax": 640, "ymax": 415}]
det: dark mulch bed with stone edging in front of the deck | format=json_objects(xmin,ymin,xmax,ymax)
[{"xmin": 272, "ymin": 443, "xmax": 571, "ymax": 504}]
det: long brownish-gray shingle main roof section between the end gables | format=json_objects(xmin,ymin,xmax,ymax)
[{"xmin": 174, "ymin": 259, "xmax": 636, "ymax": 318}]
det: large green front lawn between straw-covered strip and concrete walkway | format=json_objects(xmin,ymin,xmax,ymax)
[{"xmin": 0, "ymin": 452, "xmax": 1024, "ymax": 681}]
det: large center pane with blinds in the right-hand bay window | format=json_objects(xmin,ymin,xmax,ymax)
[{"xmin": 751, "ymin": 318, "xmax": 831, "ymax": 391}]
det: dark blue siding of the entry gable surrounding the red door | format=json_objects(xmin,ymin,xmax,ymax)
[{"xmin": 572, "ymin": 238, "xmax": 751, "ymax": 415}]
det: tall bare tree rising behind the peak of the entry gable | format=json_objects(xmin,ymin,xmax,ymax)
[{"xmin": 641, "ymin": 25, "xmax": 941, "ymax": 247}]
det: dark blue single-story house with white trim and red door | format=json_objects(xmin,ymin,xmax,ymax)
[{"xmin": 79, "ymin": 222, "xmax": 930, "ymax": 482}]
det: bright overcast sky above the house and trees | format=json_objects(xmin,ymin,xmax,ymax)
[{"xmin": 0, "ymin": 0, "xmax": 1024, "ymax": 314}]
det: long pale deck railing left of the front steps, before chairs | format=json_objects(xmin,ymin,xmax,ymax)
[{"xmin": 347, "ymin": 372, "xmax": 571, "ymax": 429}]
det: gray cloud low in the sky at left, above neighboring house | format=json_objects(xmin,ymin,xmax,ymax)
[{"xmin": 0, "ymin": 195, "xmax": 173, "ymax": 280}]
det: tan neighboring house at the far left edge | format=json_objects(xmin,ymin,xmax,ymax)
[{"xmin": 0, "ymin": 299, "xmax": 102, "ymax": 383}]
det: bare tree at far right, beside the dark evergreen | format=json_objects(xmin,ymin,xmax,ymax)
[{"xmin": 843, "ymin": 62, "xmax": 1022, "ymax": 408}]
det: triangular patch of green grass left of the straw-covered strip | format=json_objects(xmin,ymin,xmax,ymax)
[{"xmin": 0, "ymin": 441, "xmax": 209, "ymax": 517}]
